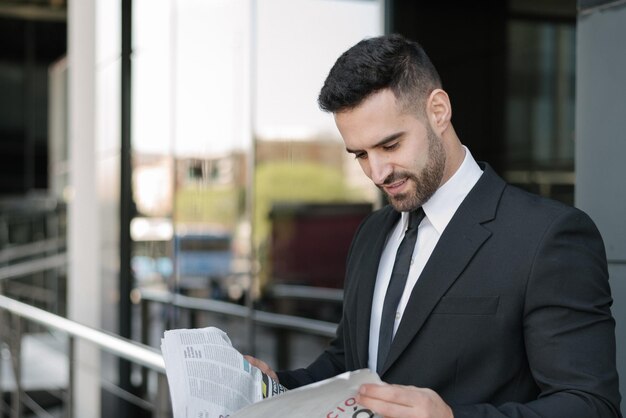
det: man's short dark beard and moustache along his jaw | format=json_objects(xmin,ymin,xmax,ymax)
[{"xmin": 381, "ymin": 126, "xmax": 446, "ymax": 212}]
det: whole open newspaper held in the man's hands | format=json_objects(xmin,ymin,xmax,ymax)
[{"xmin": 161, "ymin": 327, "xmax": 381, "ymax": 418}]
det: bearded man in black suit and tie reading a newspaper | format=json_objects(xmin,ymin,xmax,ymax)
[{"xmin": 245, "ymin": 35, "xmax": 621, "ymax": 418}]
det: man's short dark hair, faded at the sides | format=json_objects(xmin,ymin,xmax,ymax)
[{"xmin": 318, "ymin": 34, "xmax": 441, "ymax": 113}]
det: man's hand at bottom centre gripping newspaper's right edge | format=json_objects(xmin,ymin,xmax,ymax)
[{"xmin": 356, "ymin": 384, "xmax": 454, "ymax": 418}]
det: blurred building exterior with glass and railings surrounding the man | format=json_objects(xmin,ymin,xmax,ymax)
[{"xmin": 0, "ymin": 0, "xmax": 626, "ymax": 417}]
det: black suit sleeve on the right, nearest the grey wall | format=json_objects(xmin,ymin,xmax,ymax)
[{"xmin": 452, "ymin": 208, "xmax": 621, "ymax": 418}]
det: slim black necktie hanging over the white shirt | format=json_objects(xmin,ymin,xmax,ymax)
[{"xmin": 376, "ymin": 207, "xmax": 424, "ymax": 372}]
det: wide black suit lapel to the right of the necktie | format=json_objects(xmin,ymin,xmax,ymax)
[{"xmin": 381, "ymin": 165, "xmax": 505, "ymax": 375}]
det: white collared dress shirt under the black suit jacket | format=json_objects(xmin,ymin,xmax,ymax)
[{"xmin": 368, "ymin": 147, "xmax": 483, "ymax": 370}]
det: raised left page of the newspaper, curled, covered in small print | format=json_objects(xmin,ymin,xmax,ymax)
[{"xmin": 161, "ymin": 327, "xmax": 286, "ymax": 418}]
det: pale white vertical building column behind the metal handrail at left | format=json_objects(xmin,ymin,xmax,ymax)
[{"xmin": 67, "ymin": 0, "xmax": 102, "ymax": 418}]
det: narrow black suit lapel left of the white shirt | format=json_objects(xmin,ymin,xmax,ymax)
[{"xmin": 352, "ymin": 207, "xmax": 400, "ymax": 368}]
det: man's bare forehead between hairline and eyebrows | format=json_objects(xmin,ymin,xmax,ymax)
[{"xmin": 335, "ymin": 89, "xmax": 425, "ymax": 149}]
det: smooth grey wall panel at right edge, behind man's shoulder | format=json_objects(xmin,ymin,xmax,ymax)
[{"xmin": 576, "ymin": 0, "xmax": 626, "ymax": 410}]
